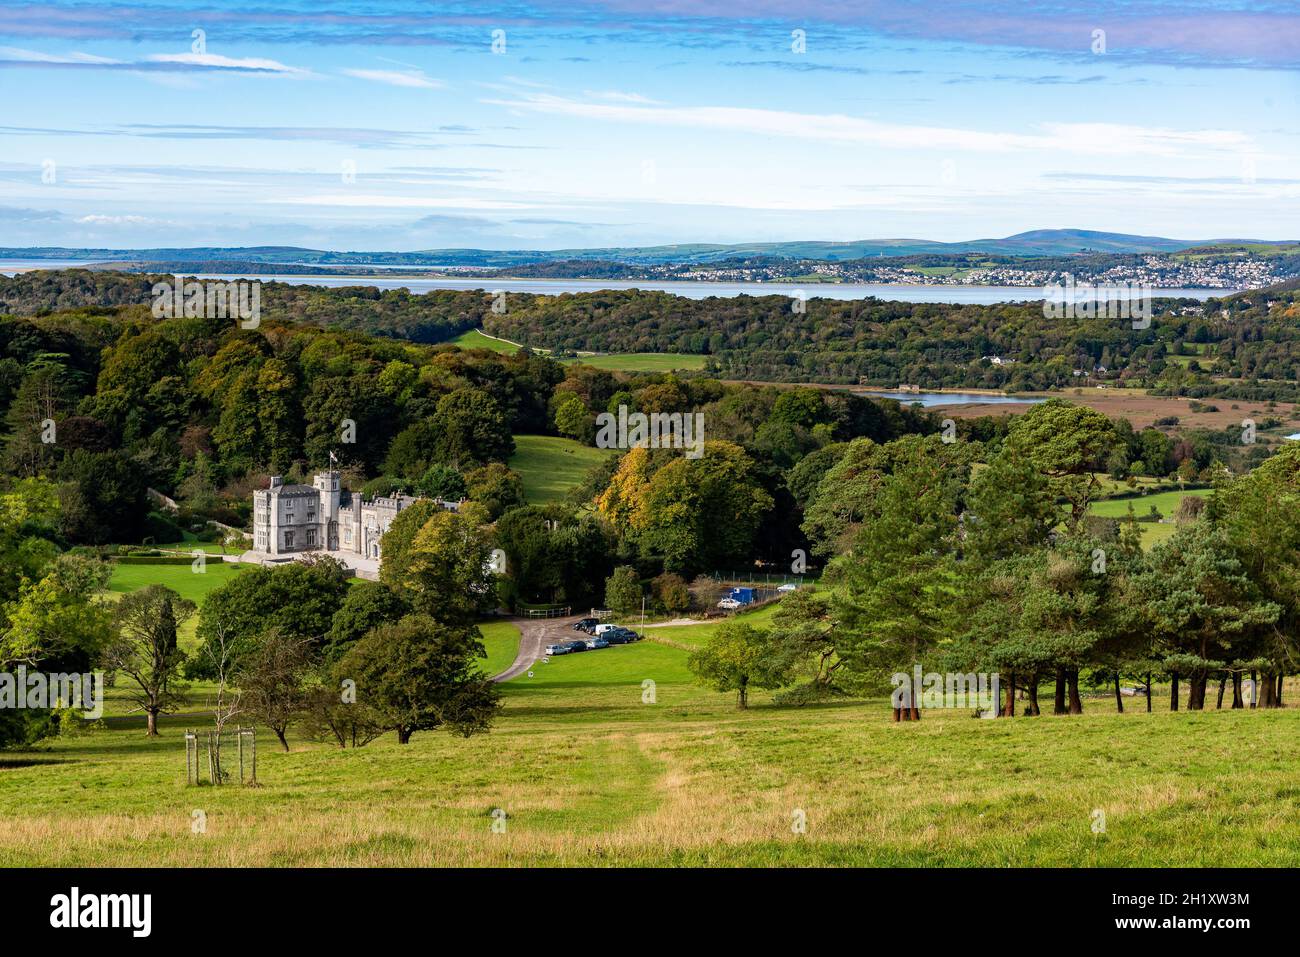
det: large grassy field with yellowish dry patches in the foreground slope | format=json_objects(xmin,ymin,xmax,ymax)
[{"xmin": 0, "ymin": 605, "xmax": 1300, "ymax": 866}]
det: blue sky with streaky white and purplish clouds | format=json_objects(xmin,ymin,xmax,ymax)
[{"xmin": 0, "ymin": 0, "xmax": 1300, "ymax": 250}]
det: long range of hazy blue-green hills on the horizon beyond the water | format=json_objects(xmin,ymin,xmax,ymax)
[{"xmin": 0, "ymin": 229, "xmax": 1275, "ymax": 268}]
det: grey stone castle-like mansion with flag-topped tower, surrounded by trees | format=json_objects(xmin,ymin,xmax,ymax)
[{"xmin": 252, "ymin": 471, "xmax": 458, "ymax": 562}]
